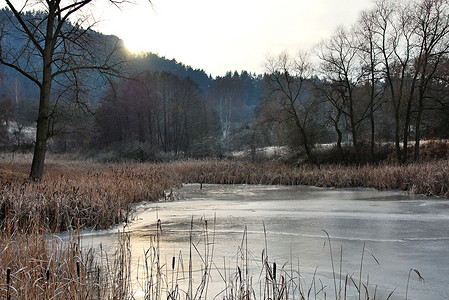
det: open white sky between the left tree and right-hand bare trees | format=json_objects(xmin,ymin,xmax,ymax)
[{"xmin": 97, "ymin": 0, "xmax": 372, "ymax": 76}]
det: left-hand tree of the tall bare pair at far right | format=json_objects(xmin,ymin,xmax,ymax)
[{"xmin": 372, "ymin": 0, "xmax": 416, "ymax": 163}]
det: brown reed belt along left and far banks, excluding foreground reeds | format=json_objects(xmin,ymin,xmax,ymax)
[{"xmin": 0, "ymin": 159, "xmax": 449, "ymax": 232}]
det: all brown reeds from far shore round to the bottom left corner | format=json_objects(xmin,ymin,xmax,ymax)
[{"xmin": 0, "ymin": 157, "xmax": 449, "ymax": 299}]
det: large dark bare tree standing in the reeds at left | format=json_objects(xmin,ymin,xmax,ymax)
[{"xmin": 0, "ymin": 0, "xmax": 126, "ymax": 180}]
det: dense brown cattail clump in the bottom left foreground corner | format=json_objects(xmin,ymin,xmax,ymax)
[{"xmin": 0, "ymin": 220, "xmax": 138, "ymax": 300}]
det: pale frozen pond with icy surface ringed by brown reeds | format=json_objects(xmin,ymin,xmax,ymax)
[{"xmin": 83, "ymin": 184, "xmax": 449, "ymax": 299}]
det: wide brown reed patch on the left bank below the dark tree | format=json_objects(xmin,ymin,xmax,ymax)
[{"xmin": 0, "ymin": 161, "xmax": 179, "ymax": 232}]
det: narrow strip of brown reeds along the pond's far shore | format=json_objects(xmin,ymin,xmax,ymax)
[{"xmin": 174, "ymin": 160, "xmax": 449, "ymax": 198}]
